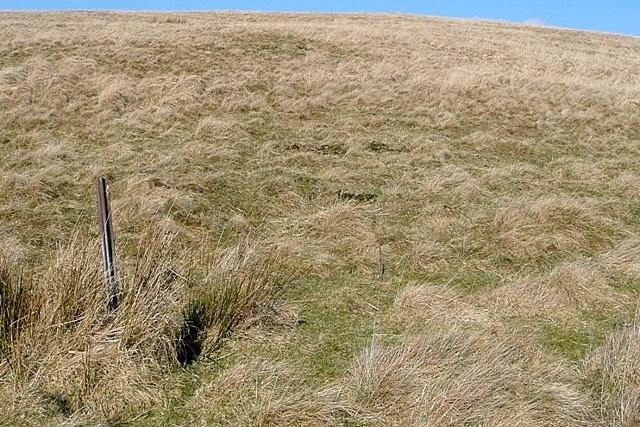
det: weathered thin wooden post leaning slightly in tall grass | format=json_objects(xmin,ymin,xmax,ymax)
[{"xmin": 97, "ymin": 178, "xmax": 120, "ymax": 312}]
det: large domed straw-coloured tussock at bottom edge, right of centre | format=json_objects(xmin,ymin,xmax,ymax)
[{"xmin": 343, "ymin": 325, "xmax": 588, "ymax": 426}]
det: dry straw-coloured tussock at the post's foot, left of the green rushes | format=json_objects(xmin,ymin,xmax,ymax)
[{"xmin": 2, "ymin": 236, "xmax": 179, "ymax": 420}]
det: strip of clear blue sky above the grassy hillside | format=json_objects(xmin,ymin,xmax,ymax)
[{"xmin": 0, "ymin": 0, "xmax": 640, "ymax": 36}]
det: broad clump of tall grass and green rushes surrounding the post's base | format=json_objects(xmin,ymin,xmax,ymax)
[{"xmin": 0, "ymin": 232, "xmax": 288, "ymax": 423}]
